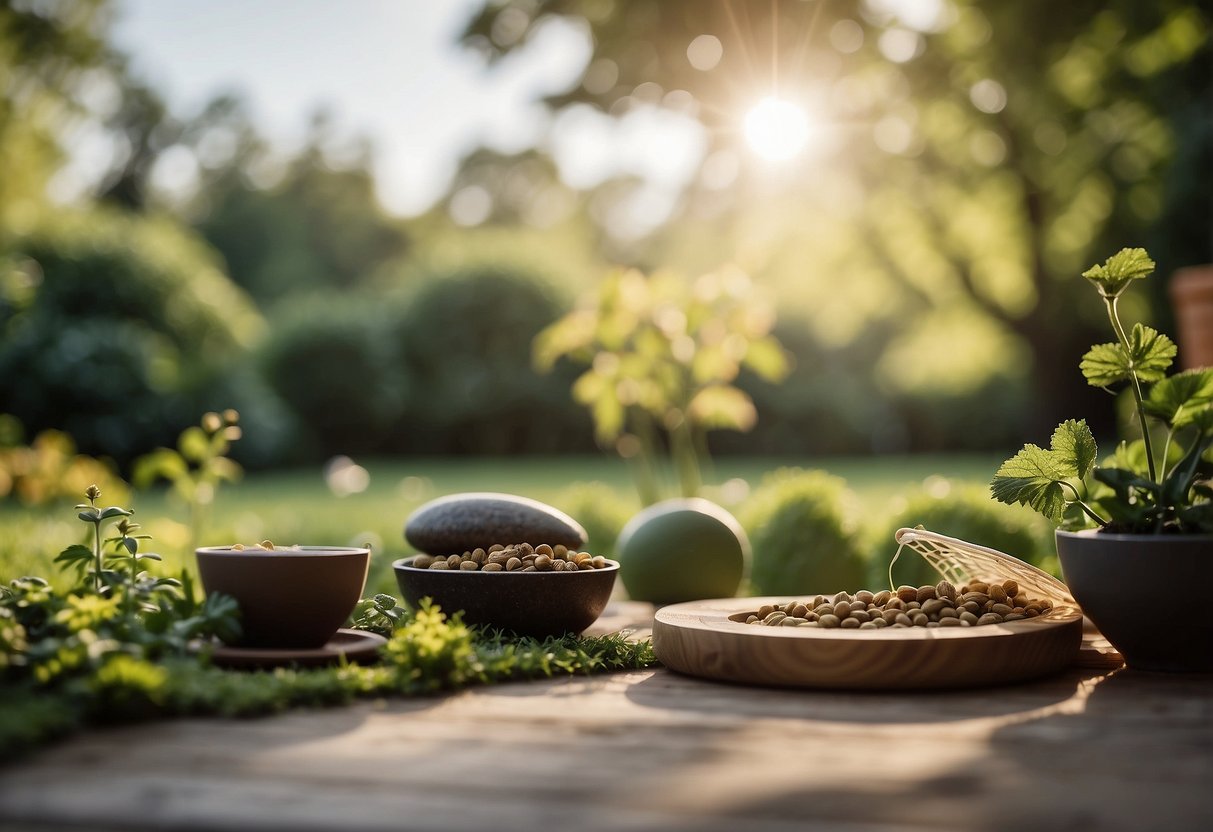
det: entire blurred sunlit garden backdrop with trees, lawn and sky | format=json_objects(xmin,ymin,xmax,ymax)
[{"xmin": 0, "ymin": 0, "xmax": 1213, "ymax": 599}]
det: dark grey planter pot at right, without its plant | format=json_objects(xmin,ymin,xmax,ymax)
[{"xmin": 1057, "ymin": 530, "xmax": 1213, "ymax": 673}]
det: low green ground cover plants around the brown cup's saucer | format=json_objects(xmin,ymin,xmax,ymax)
[{"xmin": 0, "ymin": 486, "xmax": 655, "ymax": 758}]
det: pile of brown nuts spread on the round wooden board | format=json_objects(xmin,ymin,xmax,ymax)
[{"xmin": 745, "ymin": 580, "xmax": 1053, "ymax": 629}]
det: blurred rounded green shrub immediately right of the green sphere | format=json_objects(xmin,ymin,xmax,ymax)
[{"xmin": 740, "ymin": 468, "xmax": 865, "ymax": 595}]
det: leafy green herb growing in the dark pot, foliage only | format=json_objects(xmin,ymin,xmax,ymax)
[{"xmin": 991, "ymin": 249, "xmax": 1213, "ymax": 534}]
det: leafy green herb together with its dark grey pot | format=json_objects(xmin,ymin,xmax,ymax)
[{"xmin": 991, "ymin": 249, "xmax": 1213, "ymax": 672}]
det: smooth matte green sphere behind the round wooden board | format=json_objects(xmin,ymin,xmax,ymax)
[{"xmin": 615, "ymin": 498, "xmax": 750, "ymax": 604}]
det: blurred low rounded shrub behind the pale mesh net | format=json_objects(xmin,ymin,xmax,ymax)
[{"xmin": 866, "ymin": 478, "xmax": 1058, "ymax": 588}]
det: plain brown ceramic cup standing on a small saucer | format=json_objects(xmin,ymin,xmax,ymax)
[{"xmin": 195, "ymin": 546, "xmax": 371, "ymax": 650}]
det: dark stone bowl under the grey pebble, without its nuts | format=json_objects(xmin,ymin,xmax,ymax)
[{"xmin": 392, "ymin": 558, "xmax": 619, "ymax": 638}]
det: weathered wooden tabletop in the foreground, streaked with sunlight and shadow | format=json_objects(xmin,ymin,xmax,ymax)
[{"xmin": 0, "ymin": 606, "xmax": 1213, "ymax": 832}]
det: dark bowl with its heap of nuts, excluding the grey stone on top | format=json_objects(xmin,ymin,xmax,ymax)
[{"xmin": 392, "ymin": 543, "xmax": 619, "ymax": 638}]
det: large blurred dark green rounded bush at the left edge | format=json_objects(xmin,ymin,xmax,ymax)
[{"xmin": 0, "ymin": 211, "xmax": 263, "ymax": 462}]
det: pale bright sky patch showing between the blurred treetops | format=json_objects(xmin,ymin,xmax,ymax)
[{"xmin": 113, "ymin": 0, "xmax": 704, "ymax": 215}]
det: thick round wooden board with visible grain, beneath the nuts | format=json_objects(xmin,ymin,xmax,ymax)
[{"xmin": 653, "ymin": 598, "xmax": 1082, "ymax": 690}]
